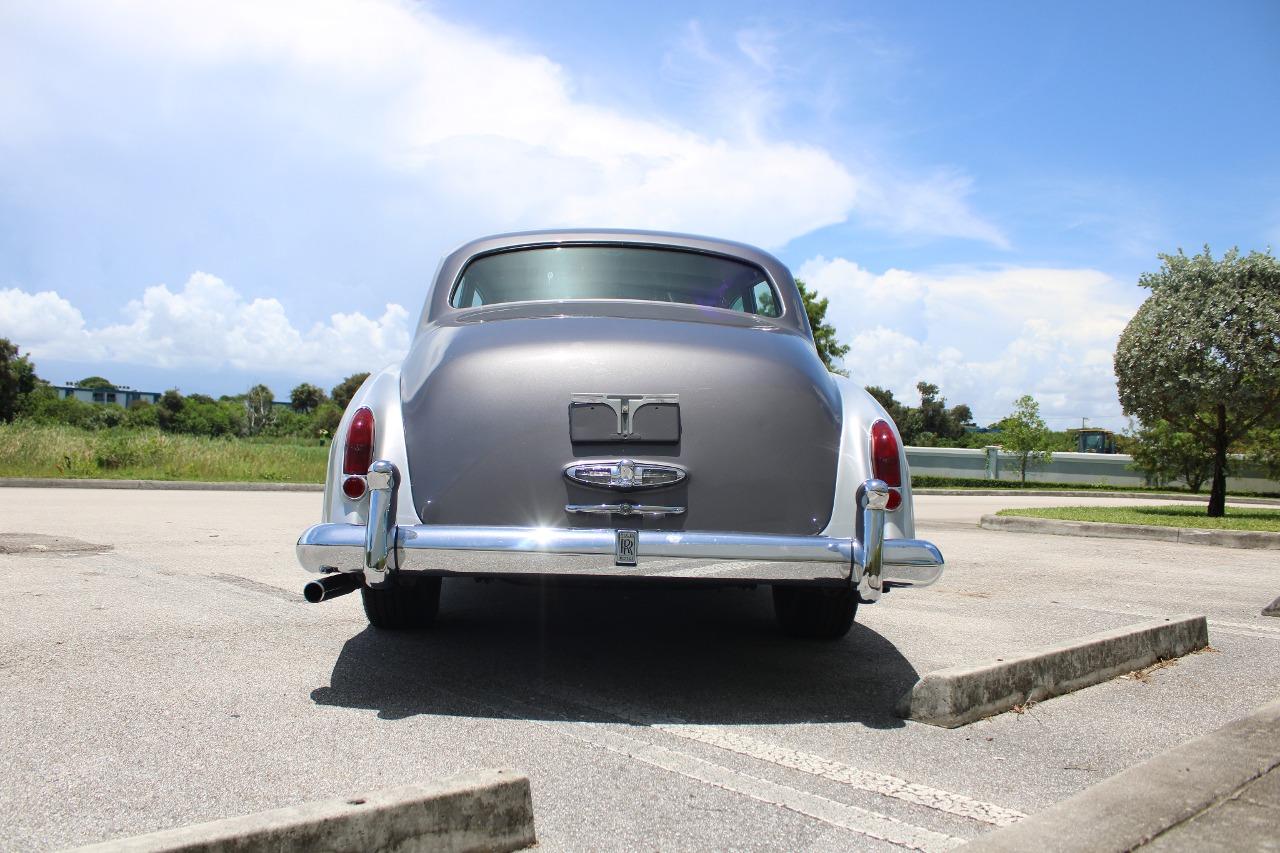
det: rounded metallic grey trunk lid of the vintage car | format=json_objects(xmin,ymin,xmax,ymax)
[{"xmin": 401, "ymin": 306, "xmax": 841, "ymax": 534}]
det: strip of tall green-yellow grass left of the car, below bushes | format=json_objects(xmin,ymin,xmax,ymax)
[{"xmin": 0, "ymin": 423, "xmax": 329, "ymax": 483}]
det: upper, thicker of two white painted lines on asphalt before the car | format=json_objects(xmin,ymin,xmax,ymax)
[{"xmin": 653, "ymin": 724, "xmax": 1027, "ymax": 826}]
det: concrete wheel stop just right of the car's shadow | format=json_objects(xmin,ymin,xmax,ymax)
[{"xmin": 897, "ymin": 616, "xmax": 1208, "ymax": 729}]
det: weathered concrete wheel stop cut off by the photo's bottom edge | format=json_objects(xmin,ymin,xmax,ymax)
[{"xmin": 69, "ymin": 770, "xmax": 536, "ymax": 853}]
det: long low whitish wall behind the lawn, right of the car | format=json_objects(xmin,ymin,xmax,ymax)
[{"xmin": 906, "ymin": 447, "xmax": 1280, "ymax": 492}]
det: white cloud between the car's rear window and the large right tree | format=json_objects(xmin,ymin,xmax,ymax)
[{"xmin": 797, "ymin": 257, "xmax": 1142, "ymax": 428}]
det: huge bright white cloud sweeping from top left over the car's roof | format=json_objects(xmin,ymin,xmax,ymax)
[{"xmin": 0, "ymin": 0, "xmax": 1005, "ymax": 247}]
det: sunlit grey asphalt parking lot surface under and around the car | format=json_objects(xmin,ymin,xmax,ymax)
[{"xmin": 0, "ymin": 488, "xmax": 1280, "ymax": 850}]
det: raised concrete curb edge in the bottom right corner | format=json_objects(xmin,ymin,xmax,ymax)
[{"xmin": 964, "ymin": 702, "xmax": 1280, "ymax": 853}]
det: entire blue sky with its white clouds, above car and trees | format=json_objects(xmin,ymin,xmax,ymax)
[{"xmin": 0, "ymin": 0, "xmax": 1280, "ymax": 427}]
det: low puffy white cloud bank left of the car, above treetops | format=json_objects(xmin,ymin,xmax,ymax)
[{"xmin": 0, "ymin": 273, "xmax": 410, "ymax": 379}]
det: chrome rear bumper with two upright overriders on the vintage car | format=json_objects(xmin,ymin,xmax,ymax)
[{"xmin": 297, "ymin": 460, "xmax": 943, "ymax": 602}]
